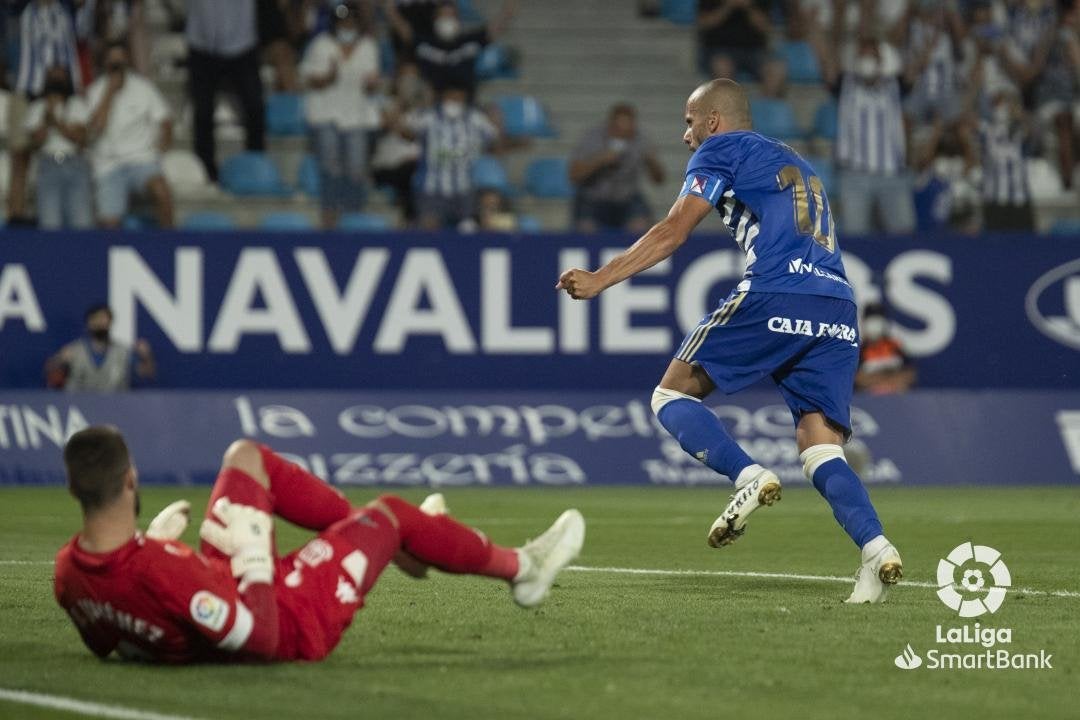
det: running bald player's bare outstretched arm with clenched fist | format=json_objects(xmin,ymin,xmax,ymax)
[{"xmin": 555, "ymin": 194, "xmax": 713, "ymax": 300}]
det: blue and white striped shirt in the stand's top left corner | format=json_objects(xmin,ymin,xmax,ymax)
[{"xmin": 15, "ymin": 0, "xmax": 82, "ymax": 95}]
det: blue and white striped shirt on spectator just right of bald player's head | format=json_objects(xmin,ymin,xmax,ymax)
[{"xmin": 836, "ymin": 73, "xmax": 907, "ymax": 175}]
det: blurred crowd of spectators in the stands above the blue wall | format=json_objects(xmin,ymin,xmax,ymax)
[{"xmin": 0, "ymin": 0, "xmax": 1080, "ymax": 234}]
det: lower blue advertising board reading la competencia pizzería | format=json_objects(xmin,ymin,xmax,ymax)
[{"xmin": 6, "ymin": 390, "xmax": 1080, "ymax": 487}]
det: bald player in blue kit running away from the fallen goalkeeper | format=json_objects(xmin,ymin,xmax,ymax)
[{"xmin": 556, "ymin": 79, "xmax": 903, "ymax": 603}]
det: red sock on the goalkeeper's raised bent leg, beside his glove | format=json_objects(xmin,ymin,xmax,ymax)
[{"xmin": 259, "ymin": 445, "xmax": 352, "ymax": 530}]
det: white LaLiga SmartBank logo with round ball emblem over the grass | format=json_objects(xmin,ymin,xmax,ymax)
[{"xmin": 893, "ymin": 542, "xmax": 1053, "ymax": 670}]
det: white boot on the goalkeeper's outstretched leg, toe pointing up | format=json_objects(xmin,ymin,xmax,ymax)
[{"xmin": 511, "ymin": 510, "xmax": 585, "ymax": 608}]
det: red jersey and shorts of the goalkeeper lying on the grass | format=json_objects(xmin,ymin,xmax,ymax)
[{"xmin": 55, "ymin": 511, "xmax": 399, "ymax": 663}]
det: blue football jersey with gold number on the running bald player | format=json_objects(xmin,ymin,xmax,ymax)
[{"xmin": 679, "ymin": 132, "xmax": 854, "ymax": 300}]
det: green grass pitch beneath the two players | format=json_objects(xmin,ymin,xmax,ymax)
[{"xmin": 0, "ymin": 487, "xmax": 1080, "ymax": 720}]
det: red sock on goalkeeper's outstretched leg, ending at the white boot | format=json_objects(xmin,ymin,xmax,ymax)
[{"xmin": 379, "ymin": 495, "xmax": 518, "ymax": 580}]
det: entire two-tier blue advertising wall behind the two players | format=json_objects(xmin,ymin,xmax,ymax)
[{"xmin": 0, "ymin": 232, "xmax": 1080, "ymax": 486}]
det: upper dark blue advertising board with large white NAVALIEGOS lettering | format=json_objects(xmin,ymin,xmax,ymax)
[{"xmin": 0, "ymin": 231, "xmax": 1080, "ymax": 391}]
